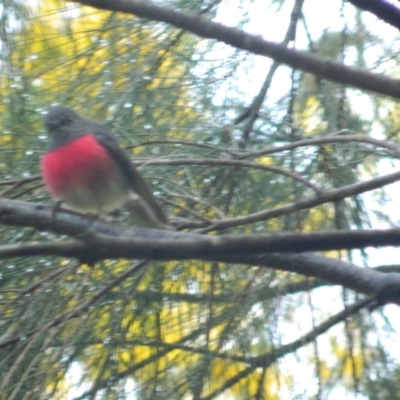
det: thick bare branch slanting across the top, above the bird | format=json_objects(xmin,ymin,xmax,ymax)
[{"xmin": 72, "ymin": 0, "xmax": 400, "ymax": 98}]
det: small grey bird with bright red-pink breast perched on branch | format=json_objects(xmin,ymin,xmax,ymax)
[{"xmin": 41, "ymin": 105, "xmax": 168, "ymax": 229}]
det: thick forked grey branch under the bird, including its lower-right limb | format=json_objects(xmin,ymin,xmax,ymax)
[{"xmin": 0, "ymin": 199, "xmax": 400, "ymax": 304}]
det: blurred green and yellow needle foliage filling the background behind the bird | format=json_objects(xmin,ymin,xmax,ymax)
[{"xmin": 0, "ymin": 0, "xmax": 400, "ymax": 400}]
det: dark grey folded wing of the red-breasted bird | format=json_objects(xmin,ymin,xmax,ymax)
[{"xmin": 88, "ymin": 120, "xmax": 168, "ymax": 224}]
